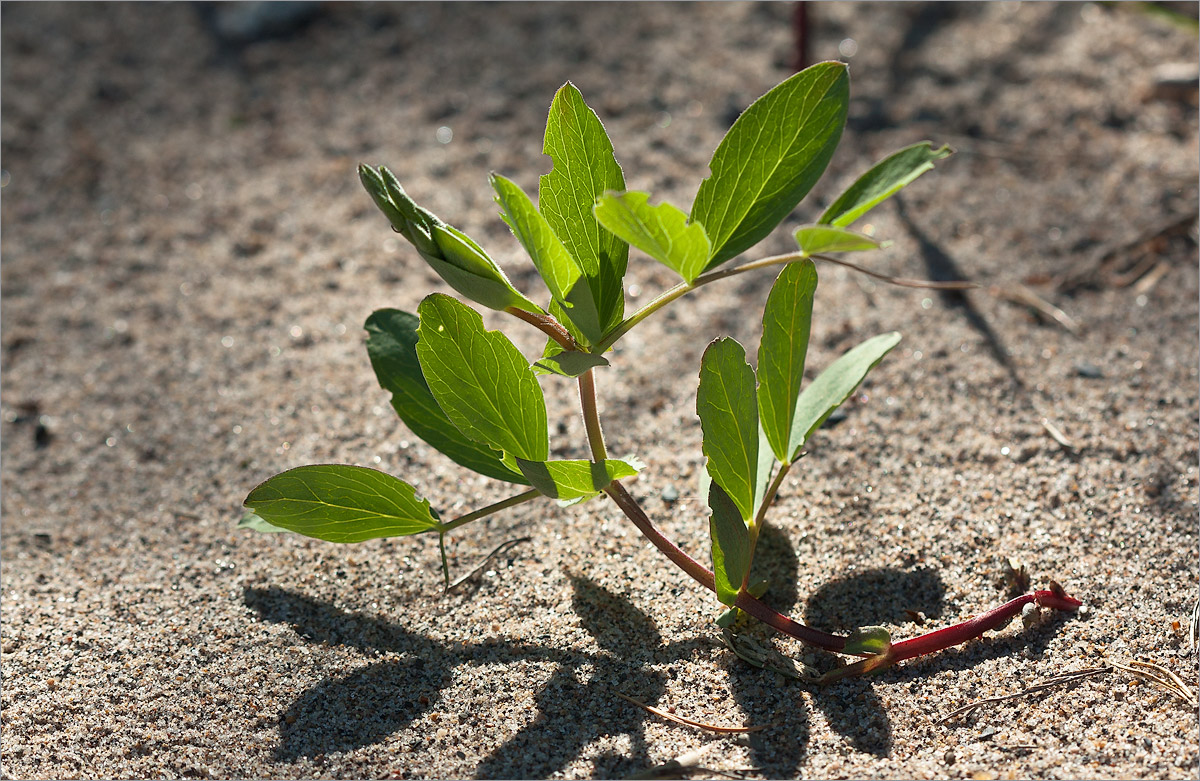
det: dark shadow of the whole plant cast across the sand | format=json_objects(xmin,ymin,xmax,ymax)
[{"xmin": 244, "ymin": 527, "xmax": 1080, "ymax": 777}]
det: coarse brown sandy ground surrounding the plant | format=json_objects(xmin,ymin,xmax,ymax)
[{"xmin": 0, "ymin": 4, "xmax": 1200, "ymax": 779}]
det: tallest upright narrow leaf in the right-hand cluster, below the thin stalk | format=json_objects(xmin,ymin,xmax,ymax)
[{"xmin": 758, "ymin": 260, "xmax": 817, "ymax": 462}]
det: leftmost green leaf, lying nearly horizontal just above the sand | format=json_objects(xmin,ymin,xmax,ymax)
[{"xmin": 245, "ymin": 464, "xmax": 442, "ymax": 542}]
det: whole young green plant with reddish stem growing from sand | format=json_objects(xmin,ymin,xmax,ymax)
[{"xmin": 241, "ymin": 62, "xmax": 1080, "ymax": 683}]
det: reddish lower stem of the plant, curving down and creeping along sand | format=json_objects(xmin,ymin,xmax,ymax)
[{"xmin": 605, "ymin": 480, "xmax": 1082, "ymax": 684}]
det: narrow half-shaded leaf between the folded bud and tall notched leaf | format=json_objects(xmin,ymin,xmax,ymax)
[{"xmin": 491, "ymin": 174, "xmax": 604, "ymax": 343}]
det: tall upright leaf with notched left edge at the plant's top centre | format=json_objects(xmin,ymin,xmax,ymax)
[{"xmin": 538, "ymin": 82, "xmax": 629, "ymax": 329}]
